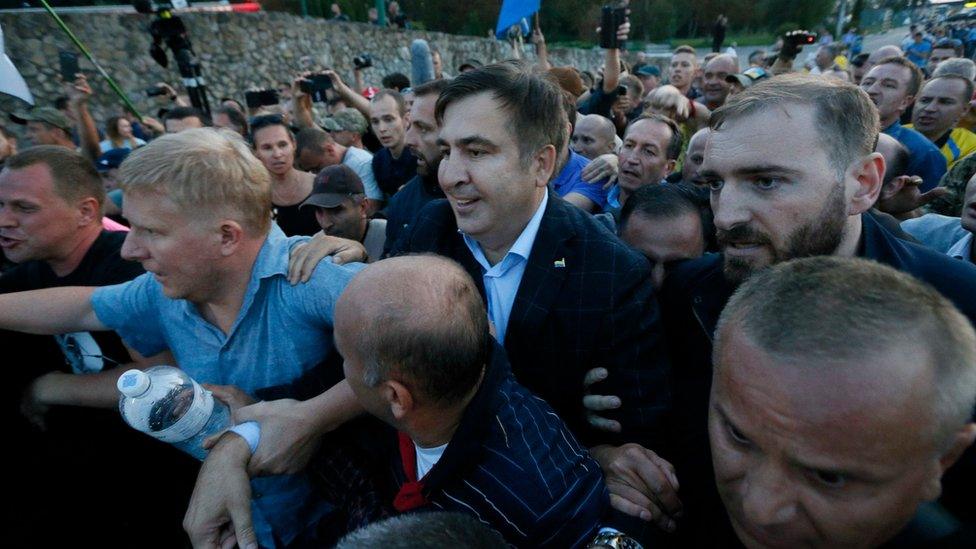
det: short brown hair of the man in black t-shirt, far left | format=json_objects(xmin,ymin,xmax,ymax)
[{"xmin": 4, "ymin": 145, "xmax": 105, "ymax": 207}]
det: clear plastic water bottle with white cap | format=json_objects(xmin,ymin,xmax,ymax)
[{"xmin": 117, "ymin": 366, "xmax": 230, "ymax": 460}]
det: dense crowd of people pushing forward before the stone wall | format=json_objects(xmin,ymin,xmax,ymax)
[{"xmin": 0, "ymin": 8, "xmax": 976, "ymax": 548}]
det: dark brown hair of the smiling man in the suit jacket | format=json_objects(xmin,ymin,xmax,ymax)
[{"xmin": 435, "ymin": 61, "xmax": 566, "ymax": 164}]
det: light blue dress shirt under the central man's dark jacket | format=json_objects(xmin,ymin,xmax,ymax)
[{"xmin": 461, "ymin": 192, "xmax": 549, "ymax": 344}]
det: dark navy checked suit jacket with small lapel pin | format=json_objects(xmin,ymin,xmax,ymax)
[{"xmin": 393, "ymin": 193, "xmax": 671, "ymax": 448}]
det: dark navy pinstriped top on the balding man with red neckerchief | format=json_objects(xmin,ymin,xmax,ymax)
[{"xmin": 391, "ymin": 345, "xmax": 609, "ymax": 547}]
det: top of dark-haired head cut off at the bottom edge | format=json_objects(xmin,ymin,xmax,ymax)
[{"xmin": 336, "ymin": 511, "xmax": 508, "ymax": 549}]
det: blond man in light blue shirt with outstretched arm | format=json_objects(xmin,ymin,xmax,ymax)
[{"xmin": 0, "ymin": 129, "xmax": 359, "ymax": 547}]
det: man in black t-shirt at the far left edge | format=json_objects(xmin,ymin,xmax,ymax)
[{"xmin": 0, "ymin": 146, "xmax": 196, "ymax": 546}]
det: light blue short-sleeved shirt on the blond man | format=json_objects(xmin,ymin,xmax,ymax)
[{"xmin": 91, "ymin": 226, "xmax": 363, "ymax": 547}]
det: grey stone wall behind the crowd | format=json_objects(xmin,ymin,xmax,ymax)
[{"xmin": 0, "ymin": 13, "xmax": 603, "ymax": 122}]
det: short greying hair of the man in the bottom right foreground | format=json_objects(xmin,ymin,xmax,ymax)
[{"xmin": 714, "ymin": 256, "xmax": 976, "ymax": 449}]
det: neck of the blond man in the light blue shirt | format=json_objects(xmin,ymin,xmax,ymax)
[{"xmin": 193, "ymin": 236, "xmax": 267, "ymax": 334}]
